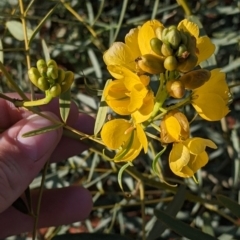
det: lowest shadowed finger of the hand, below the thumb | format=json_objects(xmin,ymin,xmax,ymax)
[{"xmin": 0, "ymin": 186, "xmax": 92, "ymax": 239}]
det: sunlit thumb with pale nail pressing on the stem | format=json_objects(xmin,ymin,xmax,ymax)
[{"xmin": 0, "ymin": 112, "xmax": 62, "ymax": 212}]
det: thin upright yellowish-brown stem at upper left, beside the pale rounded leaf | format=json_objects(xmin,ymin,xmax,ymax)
[{"xmin": 18, "ymin": 0, "xmax": 34, "ymax": 99}]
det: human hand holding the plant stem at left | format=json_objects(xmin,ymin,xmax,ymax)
[{"xmin": 0, "ymin": 94, "xmax": 94, "ymax": 239}]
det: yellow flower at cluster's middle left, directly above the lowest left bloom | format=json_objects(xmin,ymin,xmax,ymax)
[{"xmin": 103, "ymin": 66, "xmax": 154, "ymax": 123}]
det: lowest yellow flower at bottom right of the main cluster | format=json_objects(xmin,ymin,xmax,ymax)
[{"xmin": 169, "ymin": 138, "xmax": 217, "ymax": 178}]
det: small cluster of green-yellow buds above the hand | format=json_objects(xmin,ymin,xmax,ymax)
[{"xmin": 28, "ymin": 59, "xmax": 74, "ymax": 97}]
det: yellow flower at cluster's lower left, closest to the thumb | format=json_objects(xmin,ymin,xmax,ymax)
[{"xmin": 101, "ymin": 119, "xmax": 148, "ymax": 162}]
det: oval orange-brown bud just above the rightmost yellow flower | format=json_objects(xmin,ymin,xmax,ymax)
[{"xmin": 179, "ymin": 69, "xmax": 211, "ymax": 90}]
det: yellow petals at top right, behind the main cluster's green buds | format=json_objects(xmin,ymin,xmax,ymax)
[{"xmin": 178, "ymin": 19, "xmax": 215, "ymax": 65}]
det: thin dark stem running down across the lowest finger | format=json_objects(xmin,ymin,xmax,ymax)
[{"xmin": 32, "ymin": 161, "xmax": 49, "ymax": 240}]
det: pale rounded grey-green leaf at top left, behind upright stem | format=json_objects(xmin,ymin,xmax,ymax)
[{"xmin": 6, "ymin": 20, "xmax": 33, "ymax": 41}]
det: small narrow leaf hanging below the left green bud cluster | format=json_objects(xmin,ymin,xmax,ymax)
[{"xmin": 59, "ymin": 89, "xmax": 71, "ymax": 123}]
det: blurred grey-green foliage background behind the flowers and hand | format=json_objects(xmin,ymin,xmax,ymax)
[{"xmin": 0, "ymin": 0, "xmax": 240, "ymax": 240}]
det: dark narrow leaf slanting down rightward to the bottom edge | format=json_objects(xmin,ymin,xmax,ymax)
[{"xmin": 155, "ymin": 210, "xmax": 217, "ymax": 240}]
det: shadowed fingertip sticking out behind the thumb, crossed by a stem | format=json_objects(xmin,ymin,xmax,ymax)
[{"xmin": 51, "ymin": 114, "xmax": 94, "ymax": 162}]
